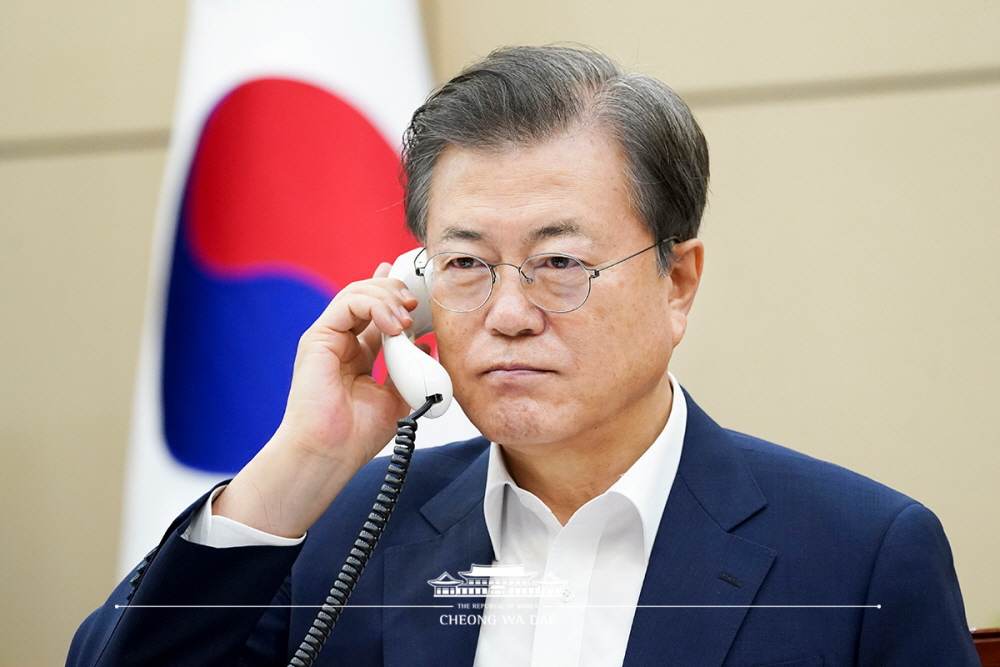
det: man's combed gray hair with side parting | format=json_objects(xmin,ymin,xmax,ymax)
[{"xmin": 403, "ymin": 46, "xmax": 709, "ymax": 268}]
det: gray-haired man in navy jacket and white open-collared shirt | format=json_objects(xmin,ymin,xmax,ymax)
[{"xmin": 64, "ymin": 47, "xmax": 977, "ymax": 667}]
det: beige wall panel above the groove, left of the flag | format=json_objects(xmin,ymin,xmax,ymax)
[{"xmin": 0, "ymin": 0, "xmax": 187, "ymax": 141}]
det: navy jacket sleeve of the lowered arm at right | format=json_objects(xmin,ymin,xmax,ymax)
[{"xmin": 857, "ymin": 503, "xmax": 980, "ymax": 667}]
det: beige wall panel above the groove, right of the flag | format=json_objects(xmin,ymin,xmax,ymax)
[{"xmin": 424, "ymin": 0, "xmax": 1000, "ymax": 91}]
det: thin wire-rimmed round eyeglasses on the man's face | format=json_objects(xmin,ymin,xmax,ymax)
[{"xmin": 415, "ymin": 238, "xmax": 677, "ymax": 313}]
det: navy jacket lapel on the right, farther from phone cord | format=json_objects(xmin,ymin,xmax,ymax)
[{"xmin": 625, "ymin": 397, "xmax": 775, "ymax": 667}]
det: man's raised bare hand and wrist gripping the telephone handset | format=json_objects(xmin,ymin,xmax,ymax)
[{"xmin": 212, "ymin": 264, "xmax": 417, "ymax": 537}]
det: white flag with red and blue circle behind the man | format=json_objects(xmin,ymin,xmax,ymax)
[{"xmin": 119, "ymin": 0, "xmax": 475, "ymax": 572}]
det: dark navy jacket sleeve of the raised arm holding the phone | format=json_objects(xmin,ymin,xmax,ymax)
[{"xmin": 66, "ymin": 495, "xmax": 301, "ymax": 667}]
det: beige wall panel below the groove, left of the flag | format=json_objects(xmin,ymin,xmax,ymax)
[{"xmin": 0, "ymin": 151, "xmax": 165, "ymax": 665}]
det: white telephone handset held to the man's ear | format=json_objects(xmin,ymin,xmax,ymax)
[{"xmin": 382, "ymin": 248, "xmax": 452, "ymax": 418}]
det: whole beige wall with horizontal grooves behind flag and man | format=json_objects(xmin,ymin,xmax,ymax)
[{"xmin": 0, "ymin": 0, "xmax": 1000, "ymax": 665}]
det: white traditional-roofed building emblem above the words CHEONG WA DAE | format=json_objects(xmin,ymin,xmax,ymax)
[{"xmin": 427, "ymin": 565, "xmax": 568, "ymax": 598}]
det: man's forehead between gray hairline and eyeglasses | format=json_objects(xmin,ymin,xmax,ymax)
[{"xmin": 427, "ymin": 128, "xmax": 648, "ymax": 249}]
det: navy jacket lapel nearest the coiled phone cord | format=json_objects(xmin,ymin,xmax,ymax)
[{"xmin": 383, "ymin": 449, "xmax": 493, "ymax": 667}]
